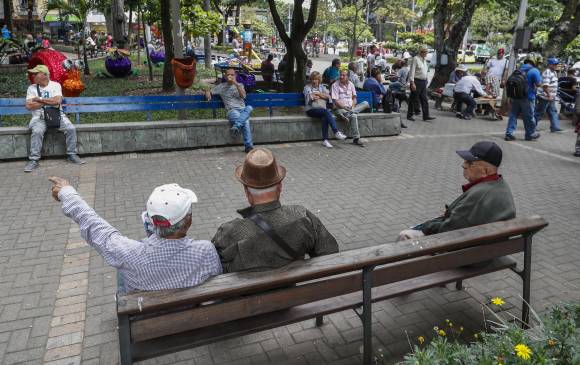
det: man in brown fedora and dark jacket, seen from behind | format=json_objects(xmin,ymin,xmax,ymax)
[{"xmin": 212, "ymin": 148, "xmax": 338, "ymax": 272}]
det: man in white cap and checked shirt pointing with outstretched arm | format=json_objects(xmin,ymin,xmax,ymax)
[{"xmin": 49, "ymin": 177, "xmax": 222, "ymax": 292}]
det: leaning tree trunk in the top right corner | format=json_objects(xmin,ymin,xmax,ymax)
[{"xmin": 542, "ymin": 0, "xmax": 580, "ymax": 57}]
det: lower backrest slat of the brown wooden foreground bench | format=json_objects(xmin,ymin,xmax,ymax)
[{"xmin": 131, "ymin": 237, "xmax": 524, "ymax": 341}]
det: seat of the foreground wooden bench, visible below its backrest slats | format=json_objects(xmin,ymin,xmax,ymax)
[{"xmin": 133, "ymin": 257, "xmax": 516, "ymax": 361}]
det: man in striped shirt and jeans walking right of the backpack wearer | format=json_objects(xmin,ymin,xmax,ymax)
[{"xmin": 534, "ymin": 57, "xmax": 562, "ymax": 133}]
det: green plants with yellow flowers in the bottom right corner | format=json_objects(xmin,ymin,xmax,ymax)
[{"xmin": 402, "ymin": 304, "xmax": 580, "ymax": 365}]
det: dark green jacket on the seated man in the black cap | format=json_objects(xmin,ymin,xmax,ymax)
[{"xmin": 421, "ymin": 177, "xmax": 516, "ymax": 235}]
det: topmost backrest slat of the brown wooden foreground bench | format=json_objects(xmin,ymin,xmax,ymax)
[{"xmin": 118, "ymin": 216, "xmax": 548, "ymax": 314}]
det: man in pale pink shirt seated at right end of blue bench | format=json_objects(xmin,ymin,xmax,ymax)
[{"xmin": 330, "ymin": 70, "xmax": 370, "ymax": 147}]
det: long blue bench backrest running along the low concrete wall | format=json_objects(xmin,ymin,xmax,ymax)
[{"xmin": 0, "ymin": 92, "xmax": 372, "ymax": 126}]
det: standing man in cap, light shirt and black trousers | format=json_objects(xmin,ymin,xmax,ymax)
[{"xmin": 407, "ymin": 46, "xmax": 435, "ymax": 122}]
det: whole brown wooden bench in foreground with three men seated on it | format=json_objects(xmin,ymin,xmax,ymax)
[{"xmin": 117, "ymin": 216, "xmax": 547, "ymax": 365}]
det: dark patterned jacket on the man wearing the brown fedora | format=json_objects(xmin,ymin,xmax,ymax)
[{"xmin": 212, "ymin": 201, "xmax": 338, "ymax": 272}]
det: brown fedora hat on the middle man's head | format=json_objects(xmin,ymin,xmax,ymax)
[{"xmin": 235, "ymin": 148, "xmax": 286, "ymax": 189}]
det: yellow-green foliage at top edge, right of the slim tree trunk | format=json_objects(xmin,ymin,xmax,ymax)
[{"xmin": 181, "ymin": 0, "xmax": 222, "ymax": 37}]
